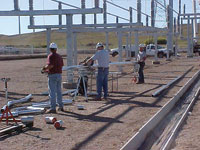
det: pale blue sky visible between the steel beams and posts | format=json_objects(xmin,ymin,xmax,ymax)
[{"xmin": 0, "ymin": 0, "xmax": 200, "ymax": 35}]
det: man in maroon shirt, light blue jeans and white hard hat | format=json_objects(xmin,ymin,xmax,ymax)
[{"xmin": 42, "ymin": 43, "xmax": 64, "ymax": 113}]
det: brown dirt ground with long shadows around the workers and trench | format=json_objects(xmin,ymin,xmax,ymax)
[{"xmin": 0, "ymin": 53, "xmax": 200, "ymax": 150}]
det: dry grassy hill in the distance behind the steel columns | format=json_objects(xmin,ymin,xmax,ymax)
[{"xmin": 0, "ymin": 25, "xmax": 194, "ymax": 49}]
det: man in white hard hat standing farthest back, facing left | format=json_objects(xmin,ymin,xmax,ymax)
[{"xmin": 136, "ymin": 45, "xmax": 146, "ymax": 84}]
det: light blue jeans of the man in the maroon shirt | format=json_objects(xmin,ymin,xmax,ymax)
[{"xmin": 48, "ymin": 73, "xmax": 63, "ymax": 110}]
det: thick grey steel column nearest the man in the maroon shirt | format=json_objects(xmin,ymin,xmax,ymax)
[{"xmin": 66, "ymin": 15, "xmax": 73, "ymax": 83}]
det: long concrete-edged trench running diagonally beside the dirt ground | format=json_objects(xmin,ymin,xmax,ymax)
[{"xmin": 121, "ymin": 71, "xmax": 200, "ymax": 150}]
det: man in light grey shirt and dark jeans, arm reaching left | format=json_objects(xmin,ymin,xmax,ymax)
[{"xmin": 87, "ymin": 43, "xmax": 110, "ymax": 100}]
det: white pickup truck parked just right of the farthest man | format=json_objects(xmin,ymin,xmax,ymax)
[{"xmin": 146, "ymin": 44, "xmax": 173, "ymax": 58}]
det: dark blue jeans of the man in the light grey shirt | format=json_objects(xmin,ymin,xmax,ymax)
[{"xmin": 97, "ymin": 68, "xmax": 109, "ymax": 98}]
